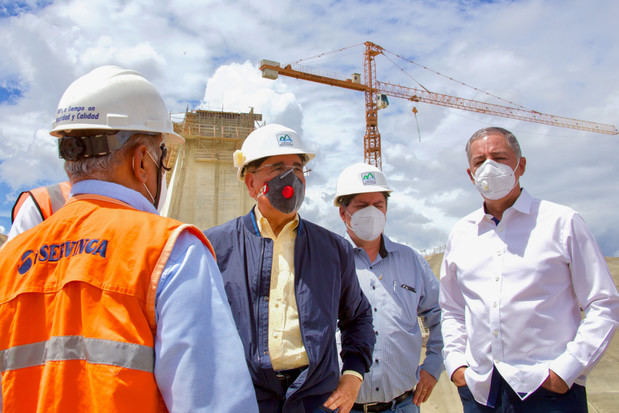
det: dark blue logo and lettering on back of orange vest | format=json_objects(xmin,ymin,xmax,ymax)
[{"xmin": 17, "ymin": 238, "xmax": 108, "ymax": 274}]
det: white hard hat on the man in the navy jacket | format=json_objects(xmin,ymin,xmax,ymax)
[{"xmin": 232, "ymin": 123, "xmax": 315, "ymax": 180}]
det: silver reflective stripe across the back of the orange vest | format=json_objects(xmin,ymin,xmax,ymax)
[{"xmin": 0, "ymin": 336, "xmax": 155, "ymax": 373}]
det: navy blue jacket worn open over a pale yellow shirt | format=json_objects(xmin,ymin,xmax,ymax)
[{"xmin": 205, "ymin": 210, "xmax": 376, "ymax": 413}]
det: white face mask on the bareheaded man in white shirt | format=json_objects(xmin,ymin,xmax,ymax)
[{"xmin": 474, "ymin": 159, "xmax": 520, "ymax": 200}]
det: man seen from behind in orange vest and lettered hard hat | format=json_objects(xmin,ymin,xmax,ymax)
[{"xmin": 0, "ymin": 66, "xmax": 257, "ymax": 413}]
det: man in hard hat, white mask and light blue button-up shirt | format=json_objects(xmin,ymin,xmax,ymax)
[{"xmin": 334, "ymin": 163, "xmax": 443, "ymax": 413}]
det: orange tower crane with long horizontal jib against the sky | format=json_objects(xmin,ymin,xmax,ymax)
[{"xmin": 260, "ymin": 41, "xmax": 619, "ymax": 168}]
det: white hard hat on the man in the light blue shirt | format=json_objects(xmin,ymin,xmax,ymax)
[{"xmin": 333, "ymin": 163, "xmax": 393, "ymax": 206}]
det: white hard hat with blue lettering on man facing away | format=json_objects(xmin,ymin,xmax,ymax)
[{"xmin": 49, "ymin": 66, "xmax": 185, "ymax": 143}]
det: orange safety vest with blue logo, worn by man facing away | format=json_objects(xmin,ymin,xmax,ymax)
[{"xmin": 0, "ymin": 195, "xmax": 215, "ymax": 413}]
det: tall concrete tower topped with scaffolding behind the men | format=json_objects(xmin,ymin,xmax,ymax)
[{"xmin": 162, "ymin": 109, "xmax": 262, "ymax": 229}]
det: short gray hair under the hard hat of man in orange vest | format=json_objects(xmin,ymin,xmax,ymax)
[{"xmin": 64, "ymin": 132, "xmax": 159, "ymax": 181}]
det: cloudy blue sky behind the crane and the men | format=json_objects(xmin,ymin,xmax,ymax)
[{"xmin": 0, "ymin": 0, "xmax": 619, "ymax": 256}]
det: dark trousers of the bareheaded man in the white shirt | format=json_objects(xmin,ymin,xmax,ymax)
[{"xmin": 458, "ymin": 369, "xmax": 588, "ymax": 413}]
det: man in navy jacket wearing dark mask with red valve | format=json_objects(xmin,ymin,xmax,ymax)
[{"xmin": 206, "ymin": 124, "xmax": 375, "ymax": 413}]
